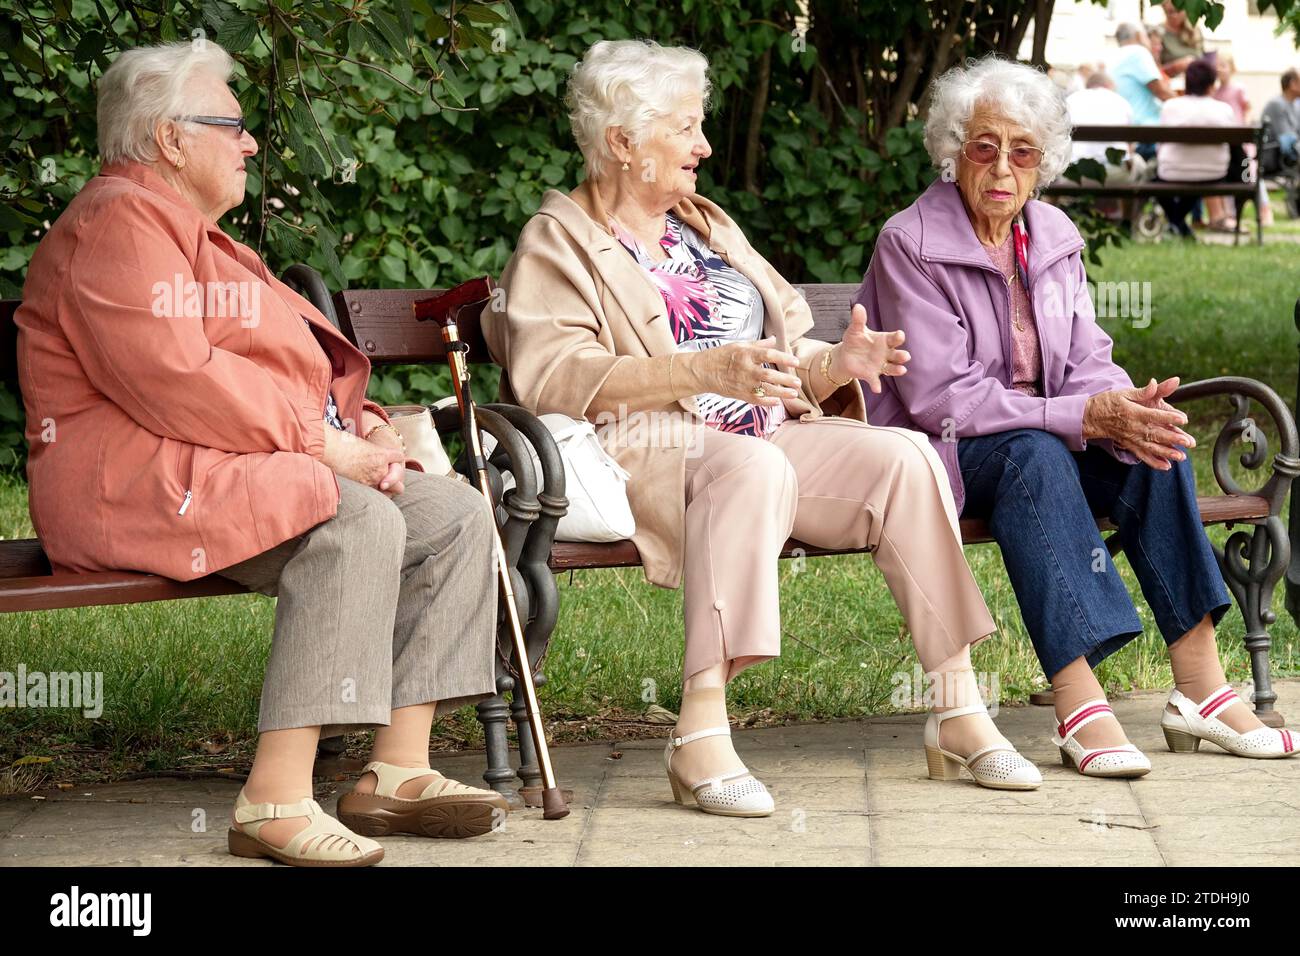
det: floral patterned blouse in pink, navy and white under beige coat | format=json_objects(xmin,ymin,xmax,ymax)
[{"xmin": 610, "ymin": 213, "xmax": 785, "ymax": 438}]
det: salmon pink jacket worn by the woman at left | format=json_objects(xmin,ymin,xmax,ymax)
[{"xmin": 16, "ymin": 163, "xmax": 420, "ymax": 580}]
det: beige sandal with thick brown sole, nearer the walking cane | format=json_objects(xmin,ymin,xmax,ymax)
[{"xmin": 338, "ymin": 761, "xmax": 510, "ymax": 839}]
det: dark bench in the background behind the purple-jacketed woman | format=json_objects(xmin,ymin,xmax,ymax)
[{"xmin": 1043, "ymin": 126, "xmax": 1264, "ymax": 245}]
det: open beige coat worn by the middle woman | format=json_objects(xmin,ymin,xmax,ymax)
[{"xmin": 484, "ymin": 181, "xmax": 866, "ymax": 588}]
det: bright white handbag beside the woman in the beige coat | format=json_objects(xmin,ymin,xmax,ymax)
[{"xmin": 493, "ymin": 412, "xmax": 637, "ymax": 542}]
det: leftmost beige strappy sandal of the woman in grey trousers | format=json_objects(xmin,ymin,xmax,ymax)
[{"xmin": 226, "ymin": 790, "xmax": 384, "ymax": 866}]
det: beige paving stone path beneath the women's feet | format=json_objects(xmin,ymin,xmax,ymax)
[{"xmin": 0, "ymin": 680, "xmax": 1300, "ymax": 866}]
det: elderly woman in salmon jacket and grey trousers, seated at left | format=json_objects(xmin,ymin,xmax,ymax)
[{"xmin": 17, "ymin": 42, "xmax": 506, "ymax": 866}]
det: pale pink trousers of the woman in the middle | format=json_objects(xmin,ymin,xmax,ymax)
[{"xmin": 684, "ymin": 418, "xmax": 995, "ymax": 680}]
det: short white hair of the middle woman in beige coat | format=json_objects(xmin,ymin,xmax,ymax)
[{"xmin": 564, "ymin": 40, "xmax": 711, "ymax": 179}]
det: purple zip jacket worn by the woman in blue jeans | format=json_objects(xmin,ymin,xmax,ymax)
[{"xmin": 853, "ymin": 179, "xmax": 1138, "ymax": 511}]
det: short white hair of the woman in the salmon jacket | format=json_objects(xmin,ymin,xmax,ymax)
[{"xmin": 96, "ymin": 40, "xmax": 234, "ymax": 163}]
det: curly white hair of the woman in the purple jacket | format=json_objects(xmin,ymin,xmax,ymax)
[{"xmin": 926, "ymin": 56, "xmax": 1073, "ymax": 193}]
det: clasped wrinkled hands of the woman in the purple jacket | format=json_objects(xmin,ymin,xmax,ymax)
[{"xmin": 1083, "ymin": 377, "xmax": 1196, "ymax": 471}]
